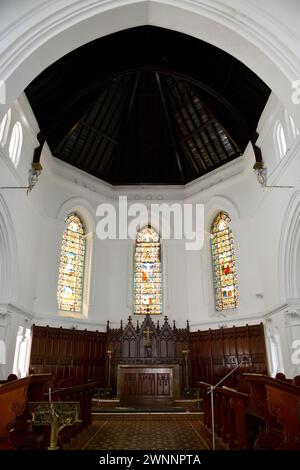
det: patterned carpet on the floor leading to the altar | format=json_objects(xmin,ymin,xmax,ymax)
[{"xmin": 69, "ymin": 413, "xmax": 208, "ymax": 450}]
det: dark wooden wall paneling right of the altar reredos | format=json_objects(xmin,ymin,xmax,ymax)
[{"xmin": 190, "ymin": 323, "xmax": 267, "ymax": 386}]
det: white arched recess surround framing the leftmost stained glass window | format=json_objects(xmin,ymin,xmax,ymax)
[{"xmin": 57, "ymin": 198, "xmax": 95, "ymax": 318}]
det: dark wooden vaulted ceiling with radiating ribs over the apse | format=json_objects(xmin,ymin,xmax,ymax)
[{"xmin": 25, "ymin": 26, "xmax": 270, "ymax": 184}]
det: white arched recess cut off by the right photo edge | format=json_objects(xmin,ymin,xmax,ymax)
[{"xmin": 278, "ymin": 190, "xmax": 300, "ymax": 302}]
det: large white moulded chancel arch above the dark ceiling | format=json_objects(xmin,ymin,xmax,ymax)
[{"xmin": 0, "ymin": 0, "xmax": 300, "ymax": 126}]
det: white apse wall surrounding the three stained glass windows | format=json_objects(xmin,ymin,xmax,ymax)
[{"xmin": 0, "ymin": 91, "xmax": 300, "ymax": 374}]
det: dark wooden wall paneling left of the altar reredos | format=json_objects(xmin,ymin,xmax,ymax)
[{"xmin": 30, "ymin": 325, "xmax": 106, "ymax": 386}]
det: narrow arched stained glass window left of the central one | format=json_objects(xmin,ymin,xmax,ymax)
[{"xmin": 57, "ymin": 214, "xmax": 85, "ymax": 312}]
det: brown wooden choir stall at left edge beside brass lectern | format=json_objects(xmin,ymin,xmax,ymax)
[{"xmin": 0, "ymin": 374, "xmax": 52, "ymax": 449}]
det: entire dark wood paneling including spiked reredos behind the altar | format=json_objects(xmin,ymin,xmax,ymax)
[{"xmin": 30, "ymin": 322, "xmax": 267, "ymax": 393}]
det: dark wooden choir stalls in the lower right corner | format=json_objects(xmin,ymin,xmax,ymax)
[{"xmin": 197, "ymin": 373, "xmax": 300, "ymax": 450}]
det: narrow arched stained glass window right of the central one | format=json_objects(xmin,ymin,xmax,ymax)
[{"xmin": 211, "ymin": 212, "xmax": 239, "ymax": 310}]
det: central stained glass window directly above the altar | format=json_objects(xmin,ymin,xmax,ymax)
[{"xmin": 134, "ymin": 227, "xmax": 162, "ymax": 315}]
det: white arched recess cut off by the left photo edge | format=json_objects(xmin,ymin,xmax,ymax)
[{"xmin": 0, "ymin": 194, "xmax": 19, "ymax": 302}]
